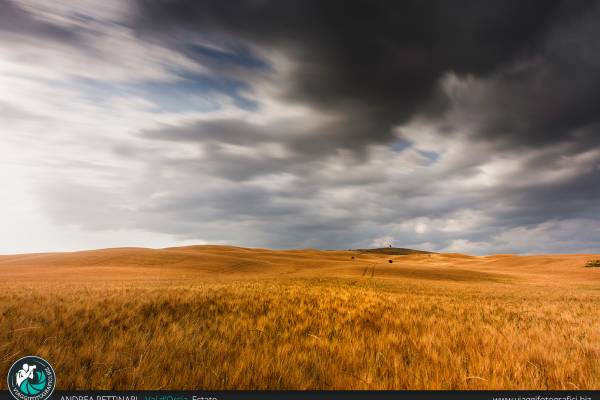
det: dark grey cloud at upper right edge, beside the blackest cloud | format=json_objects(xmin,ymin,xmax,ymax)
[{"xmin": 470, "ymin": 4, "xmax": 600, "ymax": 150}]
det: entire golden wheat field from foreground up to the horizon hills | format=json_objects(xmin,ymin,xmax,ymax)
[{"xmin": 0, "ymin": 246, "xmax": 600, "ymax": 389}]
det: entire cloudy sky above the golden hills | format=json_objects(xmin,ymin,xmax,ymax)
[{"xmin": 0, "ymin": 0, "xmax": 600, "ymax": 254}]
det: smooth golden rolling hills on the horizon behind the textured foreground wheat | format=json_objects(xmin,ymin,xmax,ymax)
[{"xmin": 0, "ymin": 245, "xmax": 600, "ymax": 286}]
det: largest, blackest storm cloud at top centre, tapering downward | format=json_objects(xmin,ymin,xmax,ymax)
[{"xmin": 137, "ymin": 0, "xmax": 590, "ymax": 149}]
